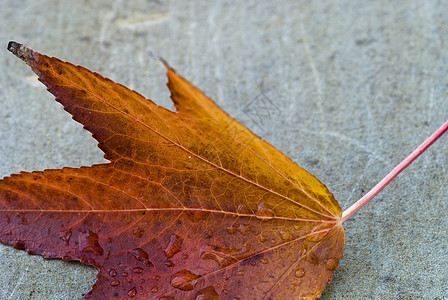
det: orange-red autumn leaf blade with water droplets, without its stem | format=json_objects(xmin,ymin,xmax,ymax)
[{"xmin": 0, "ymin": 42, "xmax": 344, "ymax": 299}]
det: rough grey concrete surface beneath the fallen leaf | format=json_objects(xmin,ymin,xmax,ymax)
[{"xmin": 0, "ymin": 0, "xmax": 448, "ymax": 300}]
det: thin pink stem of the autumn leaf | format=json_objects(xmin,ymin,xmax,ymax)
[{"xmin": 340, "ymin": 121, "xmax": 448, "ymax": 224}]
